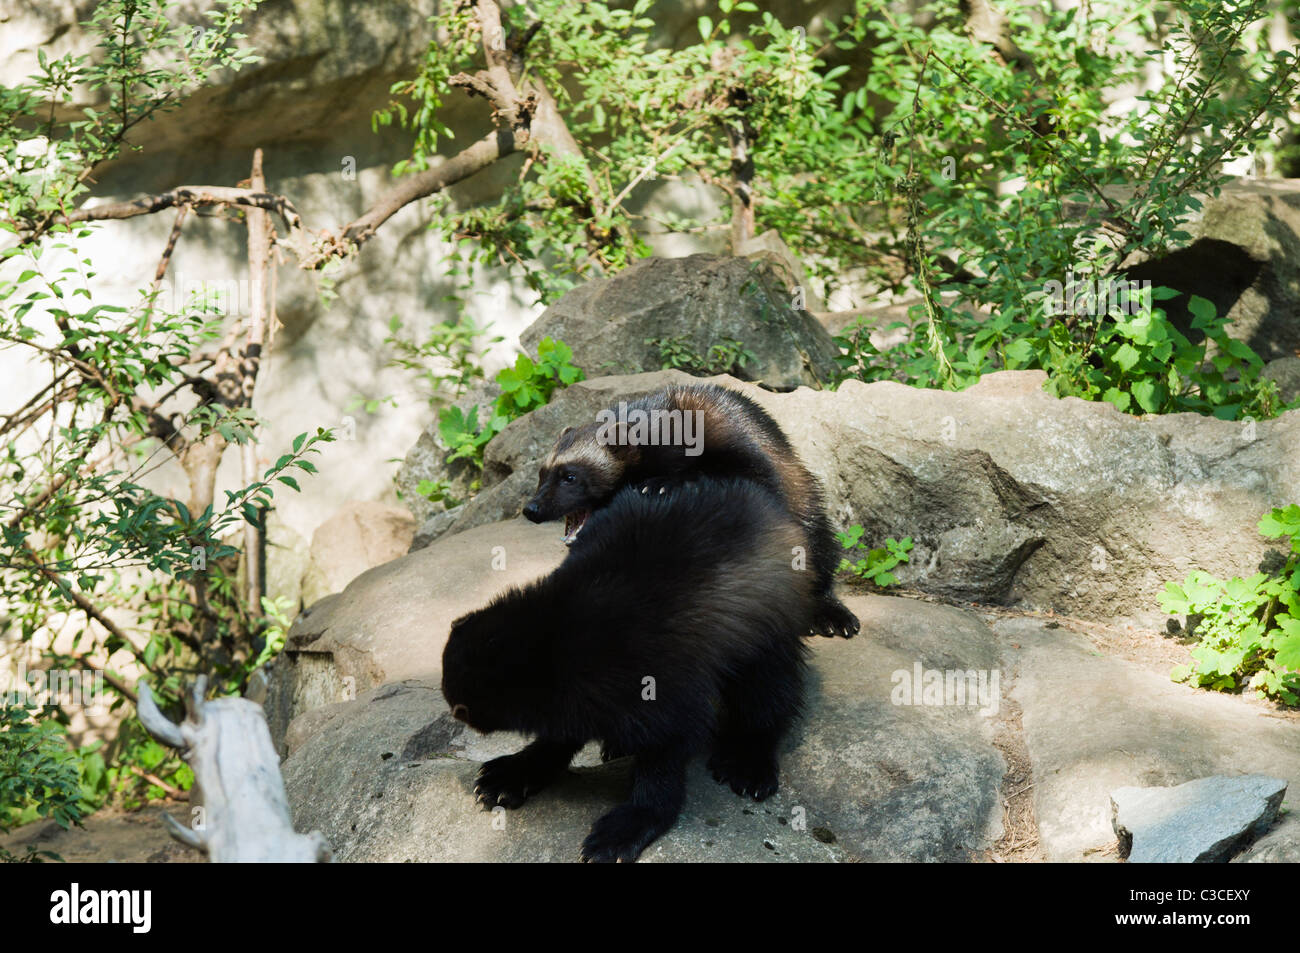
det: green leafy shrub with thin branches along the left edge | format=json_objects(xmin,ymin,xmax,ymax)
[{"xmin": 0, "ymin": 0, "xmax": 332, "ymax": 819}]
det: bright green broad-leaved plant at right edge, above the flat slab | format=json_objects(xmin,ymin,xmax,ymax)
[{"xmin": 1158, "ymin": 504, "xmax": 1300, "ymax": 705}]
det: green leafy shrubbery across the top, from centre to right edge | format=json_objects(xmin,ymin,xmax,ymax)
[{"xmin": 376, "ymin": 0, "xmax": 1300, "ymax": 417}]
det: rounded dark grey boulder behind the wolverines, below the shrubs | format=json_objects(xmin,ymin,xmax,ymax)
[{"xmin": 520, "ymin": 252, "xmax": 839, "ymax": 390}]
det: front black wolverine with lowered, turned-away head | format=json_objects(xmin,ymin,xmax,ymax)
[{"xmin": 442, "ymin": 476, "xmax": 816, "ymax": 862}]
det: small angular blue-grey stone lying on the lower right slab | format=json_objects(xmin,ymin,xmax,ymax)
[{"xmin": 1110, "ymin": 775, "xmax": 1287, "ymax": 863}]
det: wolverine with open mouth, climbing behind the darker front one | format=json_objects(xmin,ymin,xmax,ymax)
[{"xmin": 524, "ymin": 384, "xmax": 859, "ymax": 638}]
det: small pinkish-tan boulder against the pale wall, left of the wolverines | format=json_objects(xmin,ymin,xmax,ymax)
[{"xmin": 302, "ymin": 502, "xmax": 415, "ymax": 606}]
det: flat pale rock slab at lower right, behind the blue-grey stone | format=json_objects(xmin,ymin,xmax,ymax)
[{"xmin": 993, "ymin": 619, "xmax": 1300, "ymax": 861}]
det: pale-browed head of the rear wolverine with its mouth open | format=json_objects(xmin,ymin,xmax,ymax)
[{"xmin": 524, "ymin": 424, "xmax": 624, "ymax": 542}]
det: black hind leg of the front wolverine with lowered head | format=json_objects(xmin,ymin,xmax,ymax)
[{"xmin": 709, "ymin": 646, "xmax": 803, "ymax": 801}]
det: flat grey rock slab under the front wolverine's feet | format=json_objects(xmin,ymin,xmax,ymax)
[{"xmin": 283, "ymin": 597, "xmax": 1005, "ymax": 862}]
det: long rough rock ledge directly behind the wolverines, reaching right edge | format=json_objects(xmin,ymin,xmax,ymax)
[{"xmin": 405, "ymin": 371, "xmax": 1300, "ymax": 625}]
